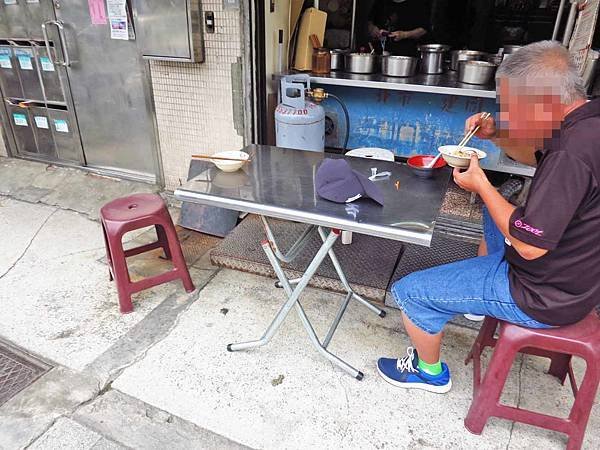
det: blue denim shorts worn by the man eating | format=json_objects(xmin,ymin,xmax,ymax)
[{"xmin": 392, "ymin": 209, "xmax": 551, "ymax": 334}]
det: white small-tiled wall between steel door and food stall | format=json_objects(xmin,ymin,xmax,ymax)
[{"xmin": 150, "ymin": 0, "xmax": 244, "ymax": 190}]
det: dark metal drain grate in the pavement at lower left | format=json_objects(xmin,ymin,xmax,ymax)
[{"xmin": 0, "ymin": 342, "xmax": 51, "ymax": 405}]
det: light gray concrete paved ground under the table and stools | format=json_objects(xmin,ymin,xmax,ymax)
[{"xmin": 0, "ymin": 159, "xmax": 600, "ymax": 450}]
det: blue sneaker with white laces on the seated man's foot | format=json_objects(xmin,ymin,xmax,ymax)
[{"xmin": 377, "ymin": 347, "xmax": 452, "ymax": 394}]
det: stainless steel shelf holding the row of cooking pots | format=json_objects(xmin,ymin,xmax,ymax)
[{"xmin": 274, "ymin": 71, "xmax": 496, "ymax": 98}]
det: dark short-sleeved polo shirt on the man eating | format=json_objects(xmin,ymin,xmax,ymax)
[{"xmin": 506, "ymin": 99, "xmax": 600, "ymax": 325}]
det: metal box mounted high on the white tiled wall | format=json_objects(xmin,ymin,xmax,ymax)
[{"xmin": 134, "ymin": 0, "xmax": 204, "ymax": 62}]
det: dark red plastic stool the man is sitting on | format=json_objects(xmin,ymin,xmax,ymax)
[{"xmin": 465, "ymin": 311, "xmax": 600, "ymax": 449}]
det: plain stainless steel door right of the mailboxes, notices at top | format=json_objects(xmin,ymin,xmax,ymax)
[{"xmin": 55, "ymin": 0, "xmax": 158, "ymax": 178}]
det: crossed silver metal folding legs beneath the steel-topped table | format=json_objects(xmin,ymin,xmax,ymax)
[{"xmin": 227, "ymin": 216, "xmax": 385, "ymax": 380}]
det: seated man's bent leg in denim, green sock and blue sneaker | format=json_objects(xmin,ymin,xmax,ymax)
[{"xmin": 378, "ymin": 253, "xmax": 511, "ymax": 393}]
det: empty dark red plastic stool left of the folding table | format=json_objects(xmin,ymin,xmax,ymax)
[{"xmin": 100, "ymin": 194, "xmax": 195, "ymax": 313}]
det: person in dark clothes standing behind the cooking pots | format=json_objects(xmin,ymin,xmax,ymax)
[{"xmin": 368, "ymin": 0, "xmax": 430, "ymax": 56}]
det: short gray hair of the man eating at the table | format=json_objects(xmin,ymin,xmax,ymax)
[{"xmin": 496, "ymin": 41, "xmax": 586, "ymax": 105}]
